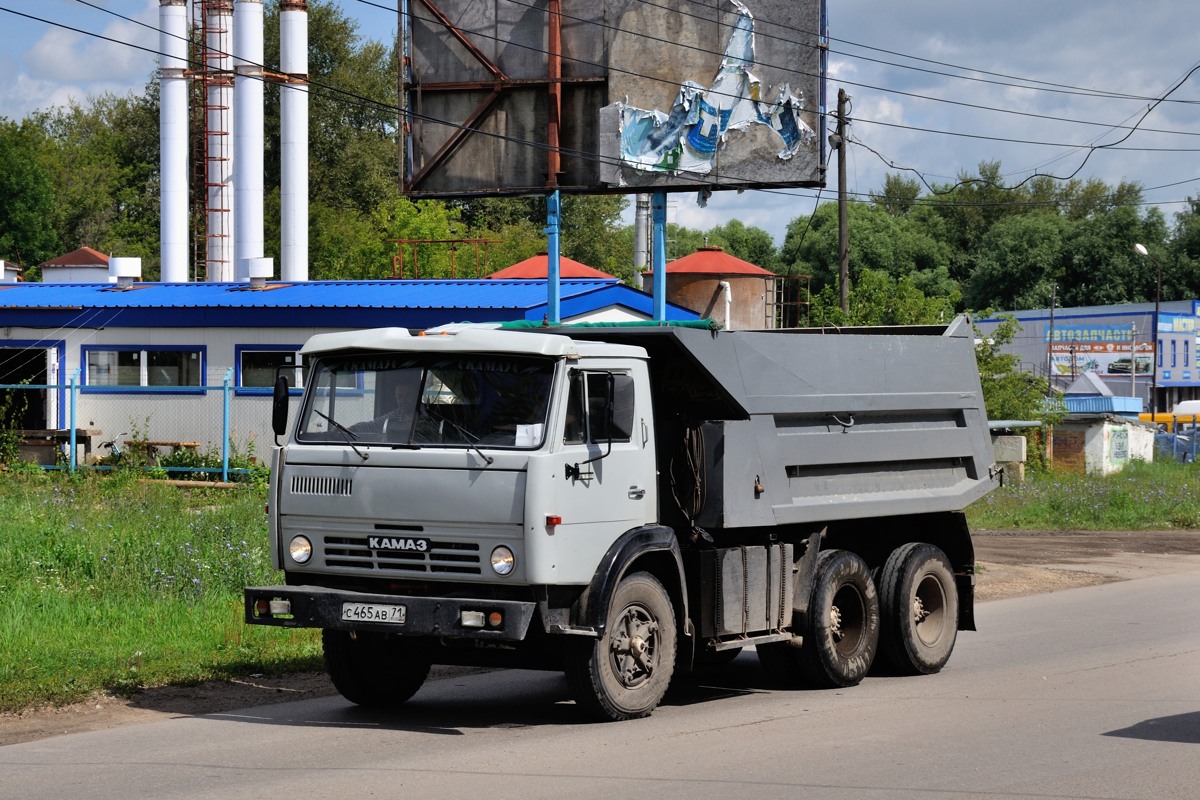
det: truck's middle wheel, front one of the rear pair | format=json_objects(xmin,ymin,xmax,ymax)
[{"xmin": 756, "ymin": 551, "xmax": 880, "ymax": 688}]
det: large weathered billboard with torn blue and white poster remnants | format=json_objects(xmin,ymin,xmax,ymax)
[{"xmin": 401, "ymin": 0, "xmax": 828, "ymax": 197}]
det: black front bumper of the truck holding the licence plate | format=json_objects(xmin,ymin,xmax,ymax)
[{"xmin": 244, "ymin": 587, "xmax": 538, "ymax": 642}]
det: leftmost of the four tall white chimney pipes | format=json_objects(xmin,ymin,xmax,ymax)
[{"xmin": 158, "ymin": 0, "xmax": 187, "ymax": 283}]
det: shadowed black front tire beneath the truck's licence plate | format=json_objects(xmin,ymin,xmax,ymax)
[{"xmin": 320, "ymin": 630, "xmax": 430, "ymax": 709}]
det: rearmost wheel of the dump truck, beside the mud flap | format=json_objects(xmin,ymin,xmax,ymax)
[{"xmin": 880, "ymin": 542, "xmax": 959, "ymax": 675}]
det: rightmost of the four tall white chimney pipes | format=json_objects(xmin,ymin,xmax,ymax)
[{"xmin": 280, "ymin": 0, "xmax": 308, "ymax": 281}]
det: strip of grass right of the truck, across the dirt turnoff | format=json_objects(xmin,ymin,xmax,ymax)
[{"xmin": 967, "ymin": 461, "xmax": 1200, "ymax": 530}]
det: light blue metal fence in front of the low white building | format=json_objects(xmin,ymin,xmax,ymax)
[{"xmin": 0, "ymin": 369, "xmax": 292, "ymax": 481}]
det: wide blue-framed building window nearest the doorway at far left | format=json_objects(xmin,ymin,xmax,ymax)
[{"xmin": 83, "ymin": 344, "xmax": 204, "ymax": 391}]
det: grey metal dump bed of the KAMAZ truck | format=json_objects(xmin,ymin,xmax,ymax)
[{"xmin": 540, "ymin": 317, "xmax": 995, "ymax": 528}]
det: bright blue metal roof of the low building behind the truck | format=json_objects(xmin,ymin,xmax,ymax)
[{"xmin": 0, "ymin": 279, "xmax": 697, "ymax": 327}]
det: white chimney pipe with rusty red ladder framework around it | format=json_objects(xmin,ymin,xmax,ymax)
[{"xmin": 205, "ymin": 2, "xmax": 234, "ymax": 283}]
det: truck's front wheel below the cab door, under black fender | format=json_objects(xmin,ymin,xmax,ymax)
[{"xmin": 564, "ymin": 572, "xmax": 676, "ymax": 722}]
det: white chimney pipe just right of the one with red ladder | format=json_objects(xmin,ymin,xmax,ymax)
[{"xmin": 233, "ymin": 0, "xmax": 264, "ymax": 281}]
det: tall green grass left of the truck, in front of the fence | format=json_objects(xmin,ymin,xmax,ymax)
[{"xmin": 0, "ymin": 474, "xmax": 322, "ymax": 711}]
